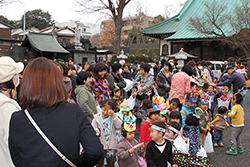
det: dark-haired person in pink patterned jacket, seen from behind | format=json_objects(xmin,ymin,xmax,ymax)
[{"xmin": 169, "ymin": 65, "xmax": 195, "ymax": 104}]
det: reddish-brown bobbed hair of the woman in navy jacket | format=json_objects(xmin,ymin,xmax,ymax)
[{"xmin": 20, "ymin": 57, "xmax": 68, "ymax": 109}]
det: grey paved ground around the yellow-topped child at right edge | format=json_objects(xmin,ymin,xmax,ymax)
[{"xmin": 208, "ymin": 91, "xmax": 250, "ymax": 167}]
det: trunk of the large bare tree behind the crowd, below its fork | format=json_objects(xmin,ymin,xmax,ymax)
[{"xmin": 113, "ymin": 15, "xmax": 122, "ymax": 54}]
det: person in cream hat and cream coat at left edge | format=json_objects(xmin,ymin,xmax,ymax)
[{"xmin": 0, "ymin": 56, "xmax": 24, "ymax": 167}]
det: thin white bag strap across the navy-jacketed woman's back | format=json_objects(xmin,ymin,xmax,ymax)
[{"xmin": 24, "ymin": 109, "xmax": 77, "ymax": 167}]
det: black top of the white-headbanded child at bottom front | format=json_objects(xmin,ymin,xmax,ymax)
[{"xmin": 146, "ymin": 139, "xmax": 173, "ymax": 167}]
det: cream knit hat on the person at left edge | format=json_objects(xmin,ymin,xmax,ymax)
[{"xmin": 0, "ymin": 56, "xmax": 24, "ymax": 83}]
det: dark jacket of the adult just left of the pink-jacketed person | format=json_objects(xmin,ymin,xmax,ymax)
[{"xmin": 156, "ymin": 71, "xmax": 173, "ymax": 97}]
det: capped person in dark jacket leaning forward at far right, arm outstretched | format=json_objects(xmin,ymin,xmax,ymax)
[{"xmin": 213, "ymin": 66, "xmax": 247, "ymax": 108}]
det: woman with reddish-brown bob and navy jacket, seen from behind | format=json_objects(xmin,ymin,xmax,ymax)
[{"xmin": 9, "ymin": 57, "xmax": 103, "ymax": 167}]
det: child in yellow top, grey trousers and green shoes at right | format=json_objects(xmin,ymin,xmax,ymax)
[{"xmin": 226, "ymin": 92, "xmax": 244, "ymax": 155}]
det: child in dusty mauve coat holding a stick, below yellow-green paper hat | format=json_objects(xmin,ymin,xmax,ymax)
[{"xmin": 117, "ymin": 126, "xmax": 144, "ymax": 167}]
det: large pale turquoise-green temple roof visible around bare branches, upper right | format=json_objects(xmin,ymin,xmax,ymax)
[{"xmin": 142, "ymin": 0, "xmax": 240, "ymax": 40}]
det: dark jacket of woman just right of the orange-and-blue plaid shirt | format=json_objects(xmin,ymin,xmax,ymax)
[{"xmin": 107, "ymin": 72, "xmax": 126, "ymax": 90}]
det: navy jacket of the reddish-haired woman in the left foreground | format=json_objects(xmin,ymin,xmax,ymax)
[{"xmin": 9, "ymin": 102, "xmax": 103, "ymax": 167}]
